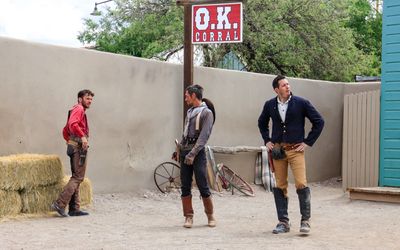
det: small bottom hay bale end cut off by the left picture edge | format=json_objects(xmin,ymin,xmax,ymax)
[{"xmin": 0, "ymin": 190, "xmax": 22, "ymax": 217}]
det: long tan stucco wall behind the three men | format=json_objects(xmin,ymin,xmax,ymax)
[{"xmin": 0, "ymin": 38, "xmax": 379, "ymax": 192}]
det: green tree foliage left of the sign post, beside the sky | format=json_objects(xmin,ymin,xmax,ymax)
[{"xmin": 78, "ymin": 0, "xmax": 183, "ymax": 58}]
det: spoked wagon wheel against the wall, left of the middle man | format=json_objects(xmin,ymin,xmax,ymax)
[{"xmin": 154, "ymin": 162, "xmax": 181, "ymax": 193}]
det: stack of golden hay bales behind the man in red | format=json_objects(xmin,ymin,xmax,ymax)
[{"xmin": 0, "ymin": 154, "xmax": 92, "ymax": 217}]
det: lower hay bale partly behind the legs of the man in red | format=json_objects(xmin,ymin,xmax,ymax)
[{"xmin": 21, "ymin": 176, "xmax": 92, "ymax": 213}]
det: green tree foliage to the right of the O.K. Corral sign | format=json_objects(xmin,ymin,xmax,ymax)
[{"xmin": 230, "ymin": 0, "xmax": 374, "ymax": 81}]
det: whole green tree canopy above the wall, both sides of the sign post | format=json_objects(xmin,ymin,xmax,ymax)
[{"xmin": 78, "ymin": 0, "xmax": 373, "ymax": 81}]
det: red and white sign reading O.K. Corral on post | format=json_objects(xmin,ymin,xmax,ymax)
[{"xmin": 192, "ymin": 3, "xmax": 243, "ymax": 44}]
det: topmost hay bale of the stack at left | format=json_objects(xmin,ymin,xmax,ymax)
[{"xmin": 0, "ymin": 154, "xmax": 64, "ymax": 190}]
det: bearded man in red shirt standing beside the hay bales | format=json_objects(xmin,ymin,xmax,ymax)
[{"xmin": 51, "ymin": 89, "xmax": 94, "ymax": 217}]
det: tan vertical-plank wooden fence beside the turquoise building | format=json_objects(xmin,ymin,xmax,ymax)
[{"xmin": 342, "ymin": 90, "xmax": 380, "ymax": 190}]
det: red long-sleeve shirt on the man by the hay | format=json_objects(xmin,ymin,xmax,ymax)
[{"xmin": 63, "ymin": 104, "xmax": 89, "ymax": 141}]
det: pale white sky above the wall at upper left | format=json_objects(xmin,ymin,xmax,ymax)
[{"xmin": 0, "ymin": 0, "xmax": 108, "ymax": 47}]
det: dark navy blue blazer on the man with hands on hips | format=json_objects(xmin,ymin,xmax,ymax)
[{"xmin": 258, "ymin": 95, "xmax": 324, "ymax": 146}]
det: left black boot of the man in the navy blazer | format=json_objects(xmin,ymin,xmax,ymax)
[{"xmin": 272, "ymin": 188, "xmax": 290, "ymax": 234}]
